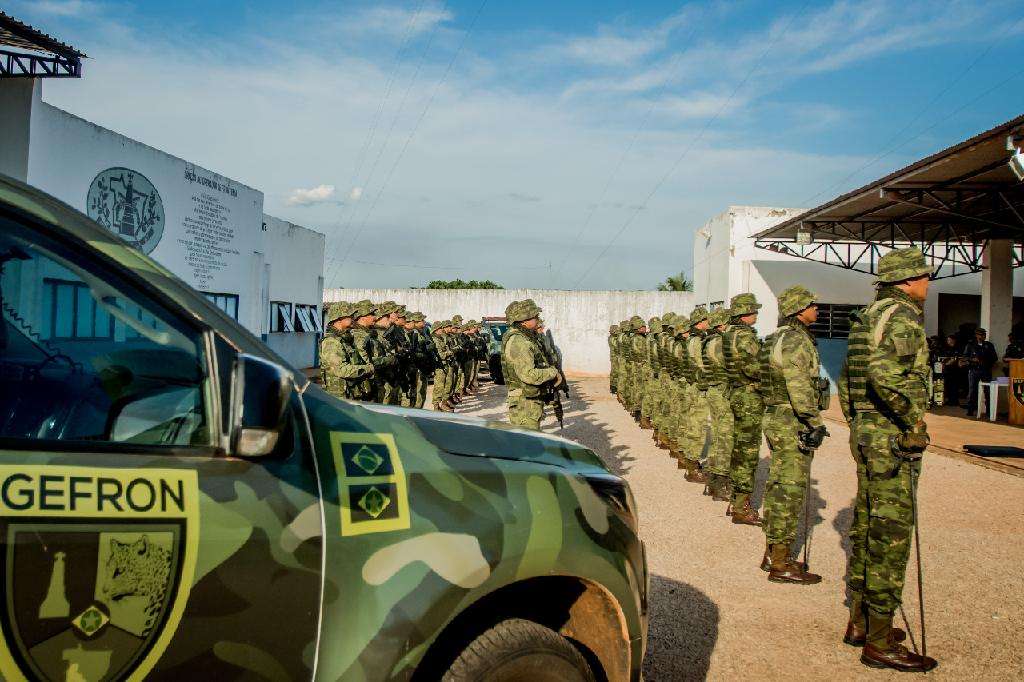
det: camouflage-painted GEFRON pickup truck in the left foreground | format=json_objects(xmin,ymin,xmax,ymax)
[{"xmin": 0, "ymin": 176, "xmax": 648, "ymax": 681}]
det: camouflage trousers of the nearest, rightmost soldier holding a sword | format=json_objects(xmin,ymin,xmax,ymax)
[{"xmin": 847, "ymin": 412, "xmax": 921, "ymax": 615}]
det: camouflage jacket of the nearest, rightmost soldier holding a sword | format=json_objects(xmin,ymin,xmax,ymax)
[{"xmin": 839, "ymin": 287, "xmax": 930, "ymax": 428}]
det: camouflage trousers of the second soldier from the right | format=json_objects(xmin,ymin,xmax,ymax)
[{"xmin": 762, "ymin": 406, "xmax": 813, "ymax": 545}]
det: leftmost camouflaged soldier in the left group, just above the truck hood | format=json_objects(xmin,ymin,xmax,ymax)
[{"xmin": 319, "ymin": 301, "xmax": 374, "ymax": 400}]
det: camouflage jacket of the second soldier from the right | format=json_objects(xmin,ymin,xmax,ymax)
[{"xmin": 760, "ymin": 319, "xmax": 822, "ymax": 428}]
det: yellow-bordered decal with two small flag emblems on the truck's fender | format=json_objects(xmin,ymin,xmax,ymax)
[{"xmin": 331, "ymin": 431, "xmax": 409, "ymax": 537}]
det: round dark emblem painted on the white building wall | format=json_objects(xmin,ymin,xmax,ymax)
[{"xmin": 86, "ymin": 167, "xmax": 164, "ymax": 254}]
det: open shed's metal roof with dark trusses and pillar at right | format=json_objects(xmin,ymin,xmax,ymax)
[{"xmin": 755, "ymin": 111, "xmax": 1024, "ymax": 346}]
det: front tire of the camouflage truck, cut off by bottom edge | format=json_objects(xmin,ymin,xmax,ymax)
[{"xmin": 441, "ymin": 619, "xmax": 595, "ymax": 682}]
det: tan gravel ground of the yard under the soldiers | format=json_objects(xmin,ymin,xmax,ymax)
[{"xmin": 440, "ymin": 378, "xmax": 1024, "ymax": 681}]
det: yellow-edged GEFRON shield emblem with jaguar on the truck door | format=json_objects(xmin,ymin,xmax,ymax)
[{"xmin": 0, "ymin": 466, "xmax": 199, "ymax": 682}]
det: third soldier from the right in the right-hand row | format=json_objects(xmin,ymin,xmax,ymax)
[{"xmin": 722, "ymin": 294, "xmax": 765, "ymax": 525}]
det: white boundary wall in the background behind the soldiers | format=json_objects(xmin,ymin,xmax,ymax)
[{"xmin": 324, "ymin": 289, "xmax": 693, "ymax": 375}]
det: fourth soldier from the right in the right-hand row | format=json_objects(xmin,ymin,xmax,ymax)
[{"xmin": 701, "ymin": 308, "xmax": 733, "ymax": 502}]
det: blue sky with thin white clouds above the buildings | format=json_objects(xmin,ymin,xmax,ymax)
[{"xmin": 4, "ymin": 0, "xmax": 1024, "ymax": 289}]
